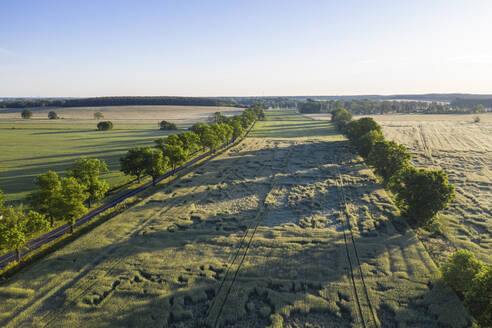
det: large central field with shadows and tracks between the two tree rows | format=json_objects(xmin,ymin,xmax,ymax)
[{"xmin": 0, "ymin": 111, "xmax": 471, "ymax": 327}]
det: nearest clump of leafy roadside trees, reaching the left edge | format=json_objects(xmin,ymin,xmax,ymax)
[{"xmin": 0, "ymin": 158, "xmax": 109, "ymax": 260}]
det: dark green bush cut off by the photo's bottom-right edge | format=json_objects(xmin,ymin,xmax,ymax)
[{"xmin": 465, "ymin": 265, "xmax": 492, "ymax": 327}]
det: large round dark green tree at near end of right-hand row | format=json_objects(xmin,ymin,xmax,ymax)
[{"xmin": 389, "ymin": 166, "xmax": 454, "ymax": 225}]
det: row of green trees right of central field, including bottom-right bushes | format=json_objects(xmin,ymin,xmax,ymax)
[{"xmin": 332, "ymin": 108, "xmax": 492, "ymax": 327}]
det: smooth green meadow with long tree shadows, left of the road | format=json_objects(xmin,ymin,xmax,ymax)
[{"xmin": 0, "ymin": 120, "xmax": 168, "ymax": 201}]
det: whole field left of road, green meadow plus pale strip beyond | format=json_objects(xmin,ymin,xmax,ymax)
[{"xmin": 0, "ymin": 106, "xmax": 240, "ymax": 201}]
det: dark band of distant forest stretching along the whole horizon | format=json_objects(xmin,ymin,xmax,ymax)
[{"xmin": 0, "ymin": 93, "xmax": 492, "ymax": 115}]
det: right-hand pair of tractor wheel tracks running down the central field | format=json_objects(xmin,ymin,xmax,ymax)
[{"xmin": 336, "ymin": 152, "xmax": 379, "ymax": 328}]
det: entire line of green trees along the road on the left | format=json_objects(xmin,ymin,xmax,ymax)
[{"xmin": 0, "ymin": 105, "xmax": 265, "ymax": 260}]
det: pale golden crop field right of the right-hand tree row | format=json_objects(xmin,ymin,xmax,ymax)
[{"xmin": 374, "ymin": 114, "xmax": 492, "ymax": 263}]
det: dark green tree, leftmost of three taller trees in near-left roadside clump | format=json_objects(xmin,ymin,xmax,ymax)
[{"xmin": 30, "ymin": 171, "xmax": 61, "ymax": 226}]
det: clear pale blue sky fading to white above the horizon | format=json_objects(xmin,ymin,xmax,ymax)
[{"xmin": 0, "ymin": 0, "xmax": 492, "ymax": 97}]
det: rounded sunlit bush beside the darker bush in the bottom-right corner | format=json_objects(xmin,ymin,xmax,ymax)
[{"xmin": 440, "ymin": 249, "xmax": 483, "ymax": 296}]
